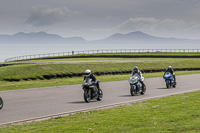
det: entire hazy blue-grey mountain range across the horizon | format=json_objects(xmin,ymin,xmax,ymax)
[{"xmin": 0, "ymin": 31, "xmax": 200, "ymax": 44}]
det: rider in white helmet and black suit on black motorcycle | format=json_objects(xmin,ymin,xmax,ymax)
[{"xmin": 84, "ymin": 69, "xmax": 100, "ymax": 97}]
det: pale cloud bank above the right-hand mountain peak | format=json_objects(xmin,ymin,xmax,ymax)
[{"xmin": 93, "ymin": 17, "xmax": 200, "ymax": 37}]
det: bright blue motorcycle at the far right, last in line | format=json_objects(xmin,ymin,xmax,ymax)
[{"xmin": 163, "ymin": 72, "xmax": 176, "ymax": 88}]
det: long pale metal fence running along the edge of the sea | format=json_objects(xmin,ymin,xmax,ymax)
[{"xmin": 5, "ymin": 49, "xmax": 200, "ymax": 62}]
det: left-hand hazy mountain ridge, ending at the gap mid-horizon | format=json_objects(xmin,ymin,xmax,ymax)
[{"xmin": 0, "ymin": 32, "xmax": 86, "ymax": 44}]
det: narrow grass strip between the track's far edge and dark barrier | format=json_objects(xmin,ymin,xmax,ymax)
[{"xmin": 0, "ymin": 71, "xmax": 200, "ymax": 91}]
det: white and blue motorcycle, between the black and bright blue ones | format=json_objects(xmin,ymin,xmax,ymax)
[{"xmin": 129, "ymin": 75, "xmax": 146, "ymax": 96}]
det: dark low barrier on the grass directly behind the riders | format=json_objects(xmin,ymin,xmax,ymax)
[{"xmin": 4, "ymin": 68, "xmax": 200, "ymax": 82}]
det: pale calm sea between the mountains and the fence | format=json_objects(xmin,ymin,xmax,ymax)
[{"xmin": 0, "ymin": 44, "xmax": 200, "ymax": 63}]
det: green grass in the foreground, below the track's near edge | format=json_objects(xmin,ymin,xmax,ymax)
[{"xmin": 0, "ymin": 88, "xmax": 200, "ymax": 133}]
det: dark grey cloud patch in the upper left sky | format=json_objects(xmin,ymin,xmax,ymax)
[{"xmin": 25, "ymin": 7, "xmax": 81, "ymax": 27}]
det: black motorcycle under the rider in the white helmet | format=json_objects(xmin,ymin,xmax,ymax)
[{"xmin": 82, "ymin": 76, "xmax": 103, "ymax": 103}]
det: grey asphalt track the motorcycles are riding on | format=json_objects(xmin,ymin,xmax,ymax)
[{"xmin": 0, "ymin": 74, "xmax": 200, "ymax": 125}]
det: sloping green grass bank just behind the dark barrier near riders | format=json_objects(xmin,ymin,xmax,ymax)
[{"xmin": 0, "ymin": 58, "xmax": 200, "ymax": 81}]
